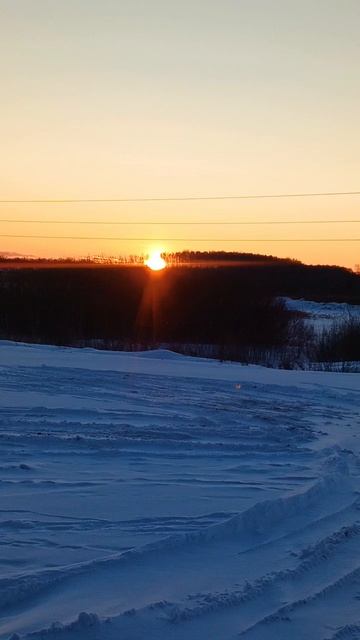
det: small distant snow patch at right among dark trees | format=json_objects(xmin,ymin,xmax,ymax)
[{"xmin": 282, "ymin": 298, "xmax": 360, "ymax": 333}]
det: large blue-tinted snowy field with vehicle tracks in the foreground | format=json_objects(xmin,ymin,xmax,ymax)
[{"xmin": 0, "ymin": 342, "xmax": 360, "ymax": 640}]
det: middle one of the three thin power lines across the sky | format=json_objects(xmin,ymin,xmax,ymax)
[{"xmin": 0, "ymin": 218, "xmax": 360, "ymax": 226}]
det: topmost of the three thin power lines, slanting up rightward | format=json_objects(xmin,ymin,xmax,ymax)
[{"xmin": 0, "ymin": 191, "xmax": 360, "ymax": 204}]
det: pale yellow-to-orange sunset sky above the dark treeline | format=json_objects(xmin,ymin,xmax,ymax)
[{"xmin": 0, "ymin": 0, "xmax": 360, "ymax": 268}]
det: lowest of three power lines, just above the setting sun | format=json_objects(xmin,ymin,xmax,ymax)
[{"xmin": 0, "ymin": 234, "xmax": 360, "ymax": 243}]
